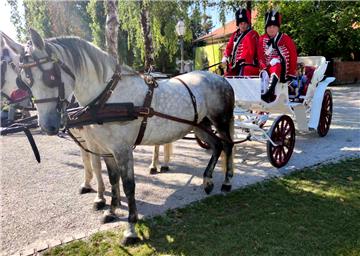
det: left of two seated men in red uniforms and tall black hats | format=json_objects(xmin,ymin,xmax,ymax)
[{"xmin": 222, "ymin": 8, "xmax": 259, "ymax": 76}]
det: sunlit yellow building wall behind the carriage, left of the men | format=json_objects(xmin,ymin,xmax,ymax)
[{"xmin": 195, "ymin": 43, "xmax": 223, "ymax": 72}]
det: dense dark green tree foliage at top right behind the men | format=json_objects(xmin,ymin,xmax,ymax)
[{"xmin": 255, "ymin": 1, "xmax": 360, "ymax": 60}]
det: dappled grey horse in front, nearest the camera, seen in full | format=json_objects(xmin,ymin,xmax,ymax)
[{"xmin": 11, "ymin": 30, "xmax": 234, "ymax": 244}]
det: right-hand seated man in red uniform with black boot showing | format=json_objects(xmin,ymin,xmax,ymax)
[{"xmin": 258, "ymin": 10, "xmax": 297, "ymax": 102}]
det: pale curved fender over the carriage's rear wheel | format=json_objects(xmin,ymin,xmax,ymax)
[{"xmin": 309, "ymin": 77, "xmax": 335, "ymax": 129}]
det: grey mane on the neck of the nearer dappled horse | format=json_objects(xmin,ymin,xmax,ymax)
[{"xmin": 45, "ymin": 36, "xmax": 116, "ymax": 81}]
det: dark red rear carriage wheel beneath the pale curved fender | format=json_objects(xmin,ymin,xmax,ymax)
[{"xmin": 317, "ymin": 90, "xmax": 332, "ymax": 137}]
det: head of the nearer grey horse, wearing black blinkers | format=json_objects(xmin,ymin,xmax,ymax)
[{"xmin": 17, "ymin": 29, "xmax": 75, "ymax": 135}]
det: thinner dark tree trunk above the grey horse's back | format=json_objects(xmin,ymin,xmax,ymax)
[{"xmin": 140, "ymin": 1, "xmax": 154, "ymax": 70}]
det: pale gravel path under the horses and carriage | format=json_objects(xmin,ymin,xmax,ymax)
[{"xmin": 0, "ymin": 87, "xmax": 360, "ymax": 255}]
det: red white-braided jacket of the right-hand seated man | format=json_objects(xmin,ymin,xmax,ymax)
[{"xmin": 258, "ymin": 32, "xmax": 297, "ymax": 82}]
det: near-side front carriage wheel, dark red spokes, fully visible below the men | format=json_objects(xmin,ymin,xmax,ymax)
[{"xmin": 267, "ymin": 115, "xmax": 295, "ymax": 168}]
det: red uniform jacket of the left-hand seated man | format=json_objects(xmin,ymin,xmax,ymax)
[{"xmin": 224, "ymin": 29, "xmax": 259, "ymax": 69}]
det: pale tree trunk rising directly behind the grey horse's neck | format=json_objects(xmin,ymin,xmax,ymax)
[{"xmin": 105, "ymin": 0, "xmax": 119, "ymax": 61}]
